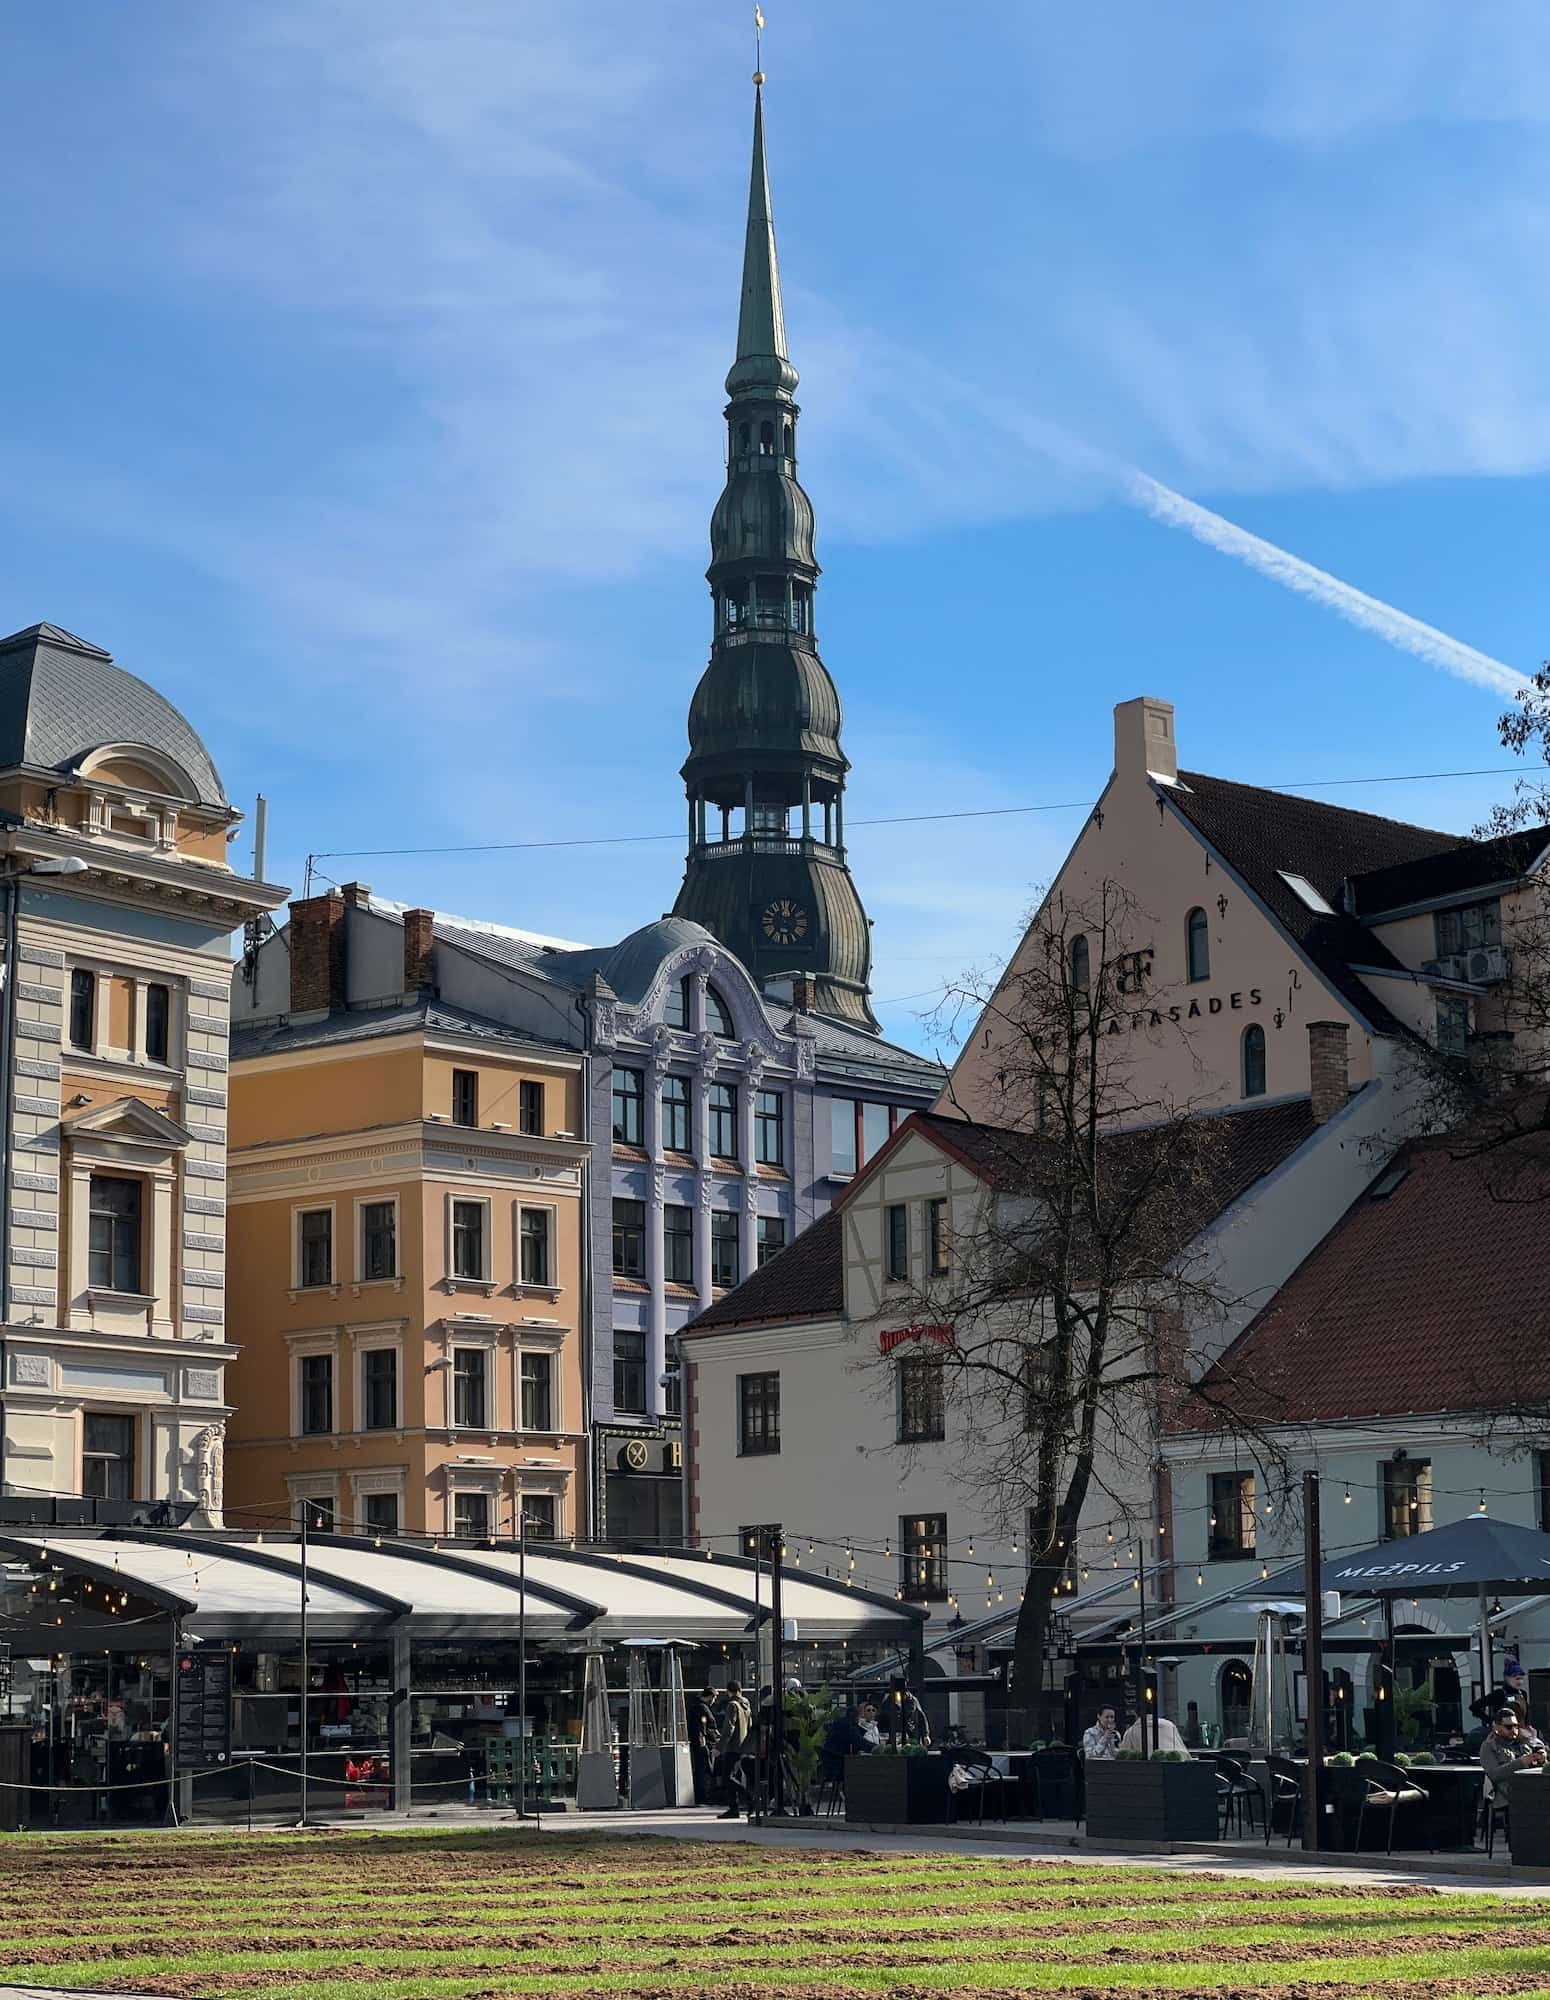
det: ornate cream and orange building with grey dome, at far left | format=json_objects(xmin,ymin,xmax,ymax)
[{"xmin": 0, "ymin": 624, "xmax": 284, "ymax": 1524}]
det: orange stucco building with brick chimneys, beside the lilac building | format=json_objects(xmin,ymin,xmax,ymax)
[{"xmin": 226, "ymin": 886, "xmax": 586, "ymax": 1538}]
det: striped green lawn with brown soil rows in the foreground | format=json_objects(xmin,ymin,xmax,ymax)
[{"xmin": 0, "ymin": 1828, "xmax": 1550, "ymax": 2000}]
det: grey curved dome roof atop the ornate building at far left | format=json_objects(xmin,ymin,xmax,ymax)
[{"xmin": 0, "ymin": 624, "xmax": 228, "ymax": 808}]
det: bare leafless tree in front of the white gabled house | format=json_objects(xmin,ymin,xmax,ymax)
[{"xmin": 876, "ymin": 882, "xmax": 1278, "ymax": 1722}]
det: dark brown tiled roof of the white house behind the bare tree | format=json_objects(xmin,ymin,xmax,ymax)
[{"xmin": 680, "ymin": 1098, "xmax": 1316, "ymax": 1338}]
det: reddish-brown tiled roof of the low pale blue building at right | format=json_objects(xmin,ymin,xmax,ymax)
[{"xmin": 1172, "ymin": 1134, "xmax": 1550, "ymax": 1430}]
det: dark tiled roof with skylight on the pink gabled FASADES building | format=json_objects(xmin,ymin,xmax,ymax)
[{"xmin": 1158, "ymin": 770, "xmax": 1458, "ymax": 1034}]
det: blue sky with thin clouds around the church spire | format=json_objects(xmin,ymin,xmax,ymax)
[{"xmin": 0, "ymin": 0, "xmax": 1550, "ymax": 1046}]
